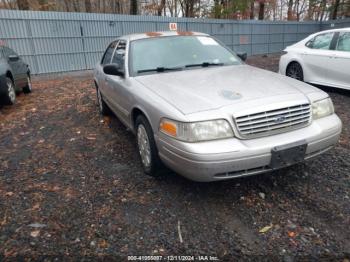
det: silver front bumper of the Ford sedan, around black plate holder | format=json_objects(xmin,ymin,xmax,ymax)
[{"xmin": 155, "ymin": 114, "xmax": 342, "ymax": 182}]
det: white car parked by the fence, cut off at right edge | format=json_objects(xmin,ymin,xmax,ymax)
[{"xmin": 279, "ymin": 28, "xmax": 350, "ymax": 89}]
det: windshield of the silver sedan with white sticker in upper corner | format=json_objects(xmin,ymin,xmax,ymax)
[{"xmin": 129, "ymin": 36, "xmax": 241, "ymax": 76}]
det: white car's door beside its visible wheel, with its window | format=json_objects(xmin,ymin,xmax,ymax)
[{"xmin": 302, "ymin": 32, "xmax": 334, "ymax": 84}]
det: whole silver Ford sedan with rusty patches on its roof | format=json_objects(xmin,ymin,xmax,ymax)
[{"xmin": 94, "ymin": 32, "xmax": 342, "ymax": 181}]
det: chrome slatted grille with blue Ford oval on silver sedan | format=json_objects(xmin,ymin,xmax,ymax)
[{"xmin": 235, "ymin": 104, "xmax": 311, "ymax": 138}]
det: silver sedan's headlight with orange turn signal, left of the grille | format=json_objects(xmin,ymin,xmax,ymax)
[{"xmin": 159, "ymin": 118, "xmax": 233, "ymax": 142}]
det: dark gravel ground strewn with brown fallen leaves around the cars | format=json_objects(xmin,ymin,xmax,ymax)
[{"xmin": 0, "ymin": 56, "xmax": 350, "ymax": 261}]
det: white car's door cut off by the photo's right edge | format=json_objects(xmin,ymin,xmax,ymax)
[{"xmin": 328, "ymin": 31, "xmax": 350, "ymax": 89}]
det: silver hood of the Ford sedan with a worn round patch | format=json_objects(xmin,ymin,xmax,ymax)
[{"xmin": 135, "ymin": 65, "xmax": 317, "ymax": 115}]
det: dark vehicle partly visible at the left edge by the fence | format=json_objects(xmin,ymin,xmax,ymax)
[{"xmin": 0, "ymin": 46, "xmax": 32, "ymax": 105}]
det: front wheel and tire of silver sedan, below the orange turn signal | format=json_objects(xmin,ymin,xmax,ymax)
[{"xmin": 135, "ymin": 115, "xmax": 163, "ymax": 177}]
